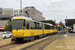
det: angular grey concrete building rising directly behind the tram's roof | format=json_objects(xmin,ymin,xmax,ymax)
[{"xmin": 23, "ymin": 7, "xmax": 45, "ymax": 21}]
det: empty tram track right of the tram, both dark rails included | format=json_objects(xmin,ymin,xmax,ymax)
[{"xmin": 21, "ymin": 36, "xmax": 59, "ymax": 50}]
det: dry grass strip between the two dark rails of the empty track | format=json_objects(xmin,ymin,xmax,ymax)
[{"xmin": 26, "ymin": 37, "xmax": 57, "ymax": 50}]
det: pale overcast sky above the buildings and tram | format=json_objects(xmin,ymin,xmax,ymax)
[{"xmin": 0, "ymin": 0, "xmax": 75, "ymax": 23}]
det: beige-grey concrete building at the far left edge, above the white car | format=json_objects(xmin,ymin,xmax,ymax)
[{"xmin": 0, "ymin": 8, "xmax": 14, "ymax": 27}]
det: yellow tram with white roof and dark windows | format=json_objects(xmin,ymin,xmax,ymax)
[{"xmin": 11, "ymin": 16, "xmax": 57, "ymax": 41}]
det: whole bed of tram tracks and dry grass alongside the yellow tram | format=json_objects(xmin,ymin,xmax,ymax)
[{"xmin": 0, "ymin": 31, "xmax": 64, "ymax": 50}]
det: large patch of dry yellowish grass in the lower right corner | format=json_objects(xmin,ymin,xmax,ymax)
[{"xmin": 44, "ymin": 37, "xmax": 75, "ymax": 50}]
